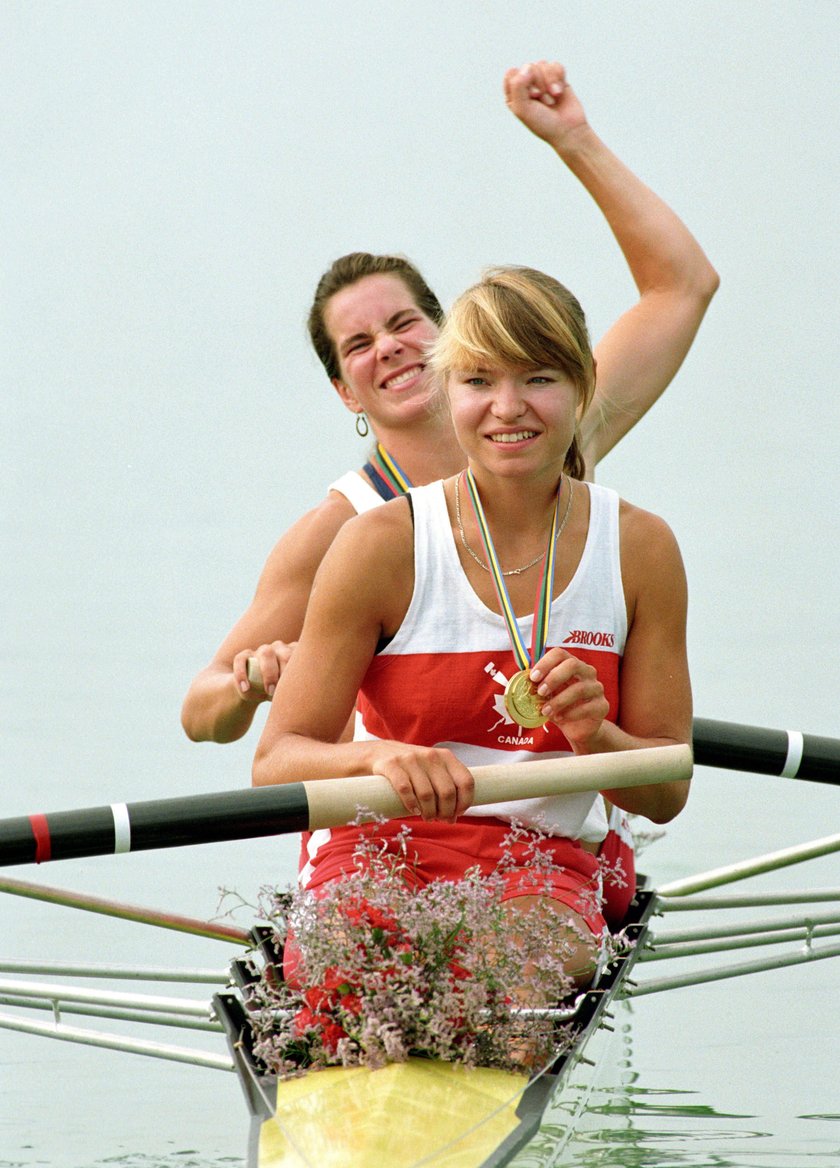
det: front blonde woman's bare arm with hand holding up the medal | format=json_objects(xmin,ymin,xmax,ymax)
[{"xmin": 532, "ymin": 502, "xmax": 692, "ymax": 823}]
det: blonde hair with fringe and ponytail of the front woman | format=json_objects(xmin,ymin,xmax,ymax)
[{"xmin": 428, "ymin": 267, "xmax": 595, "ymax": 479}]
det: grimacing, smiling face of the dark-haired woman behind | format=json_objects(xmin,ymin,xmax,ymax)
[{"xmin": 324, "ymin": 274, "xmax": 438, "ymax": 434}]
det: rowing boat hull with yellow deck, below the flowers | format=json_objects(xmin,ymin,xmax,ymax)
[{"xmin": 214, "ymin": 878, "xmax": 654, "ymax": 1168}]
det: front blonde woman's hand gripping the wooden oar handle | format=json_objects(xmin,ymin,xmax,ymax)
[{"xmin": 372, "ymin": 742, "xmax": 474, "ymax": 823}]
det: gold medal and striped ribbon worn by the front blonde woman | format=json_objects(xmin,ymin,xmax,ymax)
[{"xmin": 463, "ymin": 470, "xmax": 563, "ymax": 729}]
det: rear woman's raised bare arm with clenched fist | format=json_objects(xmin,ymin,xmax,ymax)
[{"xmin": 505, "ymin": 62, "xmax": 718, "ymax": 472}]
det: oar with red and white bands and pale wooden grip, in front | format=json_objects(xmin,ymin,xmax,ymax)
[{"xmin": 0, "ymin": 746, "xmax": 692, "ymax": 867}]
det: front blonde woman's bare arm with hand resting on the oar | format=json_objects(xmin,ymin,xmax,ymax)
[{"xmin": 254, "ymin": 500, "xmax": 473, "ymax": 821}]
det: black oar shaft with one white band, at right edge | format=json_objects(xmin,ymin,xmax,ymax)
[{"xmin": 694, "ymin": 718, "xmax": 840, "ymax": 784}]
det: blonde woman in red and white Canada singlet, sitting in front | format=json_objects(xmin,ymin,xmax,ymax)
[{"xmin": 254, "ymin": 267, "xmax": 692, "ymax": 985}]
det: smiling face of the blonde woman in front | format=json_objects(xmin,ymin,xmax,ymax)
[{"xmin": 447, "ymin": 368, "xmax": 581, "ymax": 481}]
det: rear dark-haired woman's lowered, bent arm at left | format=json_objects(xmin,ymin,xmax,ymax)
[{"xmin": 181, "ymin": 494, "xmax": 355, "ymax": 742}]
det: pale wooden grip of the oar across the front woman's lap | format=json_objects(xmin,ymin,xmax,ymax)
[{"xmin": 303, "ymin": 745, "xmax": 693, "ymax": 832}]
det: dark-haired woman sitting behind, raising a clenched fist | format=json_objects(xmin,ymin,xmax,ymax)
[{"xmin": 181, "ymin": 62, "xmax": 717, "ymax": 743}]
